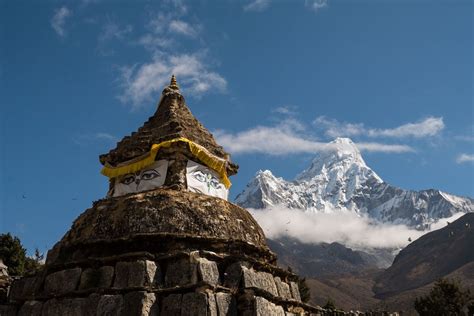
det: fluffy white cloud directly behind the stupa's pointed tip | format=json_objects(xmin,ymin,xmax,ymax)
[{"xmin": 120, "ymin": 54, "xmax": 227, "ymax": 108}]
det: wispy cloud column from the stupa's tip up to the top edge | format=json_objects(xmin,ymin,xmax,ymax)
[{"xmin": 118, "ymin": 4, "xmax": 227, "ymax": 109}]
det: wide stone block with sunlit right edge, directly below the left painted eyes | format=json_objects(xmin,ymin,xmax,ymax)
[{"xmin": 114, "ymin": 260, "xmax": 160, "ymax": 288}]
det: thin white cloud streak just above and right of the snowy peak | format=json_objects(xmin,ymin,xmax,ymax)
[{"xmin": 314, "ymin": 116, "xmax": 445, "ymax": 138}]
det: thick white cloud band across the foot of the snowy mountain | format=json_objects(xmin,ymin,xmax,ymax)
[{"xmin": 249, "ymin": 206, "xmax": 464, "ymax": 249}]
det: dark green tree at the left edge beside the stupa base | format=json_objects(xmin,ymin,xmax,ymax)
[{"xmin": 0, "ymin": 233, "xmax": 26, "ymax": 276}]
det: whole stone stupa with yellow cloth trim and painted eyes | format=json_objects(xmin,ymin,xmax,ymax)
[{"xmin": 0, "ymin": 76, "xmax": 324, "ymax": 316}]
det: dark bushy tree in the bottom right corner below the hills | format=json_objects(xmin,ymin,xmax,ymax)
[{"xmin": 415, "ymin": 279, "xmax": 473, "ymax": 316}]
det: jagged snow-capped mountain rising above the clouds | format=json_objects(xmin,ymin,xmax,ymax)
[{"xmin": 236, "ymin": 138, "xmax": 474, "ymax": 229}]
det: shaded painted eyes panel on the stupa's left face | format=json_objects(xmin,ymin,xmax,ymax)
[{"xmin": 112, "ymin": 160, "xmax": 168, "ymax": 196}]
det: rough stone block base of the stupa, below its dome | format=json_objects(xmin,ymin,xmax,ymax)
[{"xmin": 0, "ymin": 251, "xmax": 400, "ymax": 316}]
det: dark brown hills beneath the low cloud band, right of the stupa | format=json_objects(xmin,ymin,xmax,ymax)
[{"xmin": 269, "ymin": 213, "xmax": 474, "ymax": 315}]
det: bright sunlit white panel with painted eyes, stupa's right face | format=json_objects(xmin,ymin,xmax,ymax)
[{"xmin": 186, "ymin": 160, "xmax": 229, "ymax": 200}]
